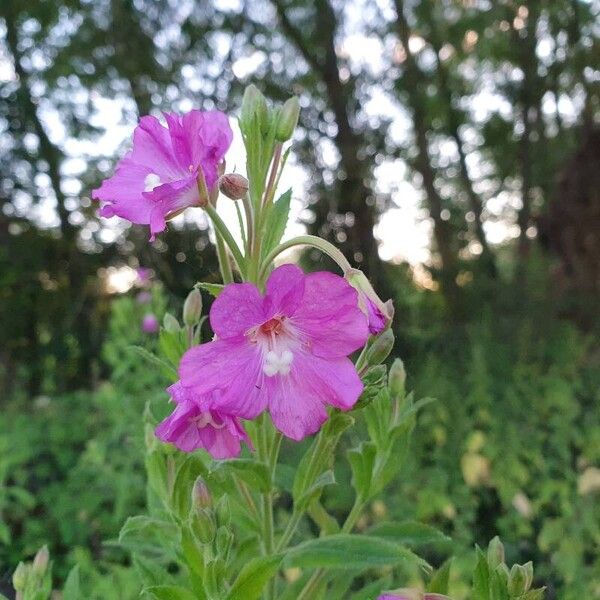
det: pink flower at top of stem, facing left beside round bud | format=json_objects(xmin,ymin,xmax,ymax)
[{"xmin": 92, "ymin": 110, "xmax": 233, "ymax": 240}]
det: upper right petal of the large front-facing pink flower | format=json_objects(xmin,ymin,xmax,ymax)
[{"xmin": 293, "ymin": 271, "xmax": 369, "ymax": 358}]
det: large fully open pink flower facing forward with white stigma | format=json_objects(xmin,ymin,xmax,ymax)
[{"xmin": 179, "ymin": 265, "xmax": 369, "ymax": 440}]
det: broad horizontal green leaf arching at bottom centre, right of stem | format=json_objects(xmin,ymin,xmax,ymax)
[{"xmin": 284, "ymin": 533, "xmax": 427, "ymax": 569}]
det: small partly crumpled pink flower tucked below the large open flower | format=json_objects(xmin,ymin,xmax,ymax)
[{"xmin": 155, "ymin": 382, "xmax": 250, "ymax": 459}]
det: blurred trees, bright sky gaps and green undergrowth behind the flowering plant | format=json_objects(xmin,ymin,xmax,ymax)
[{"xmin": 0, "ymin": 0, "xmax": 600, "ymax": 600}]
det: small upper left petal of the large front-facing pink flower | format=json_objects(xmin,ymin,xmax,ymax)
[{"xmin": 210, "ymin": 283, "xmax": 265, "ymax": 339}]
